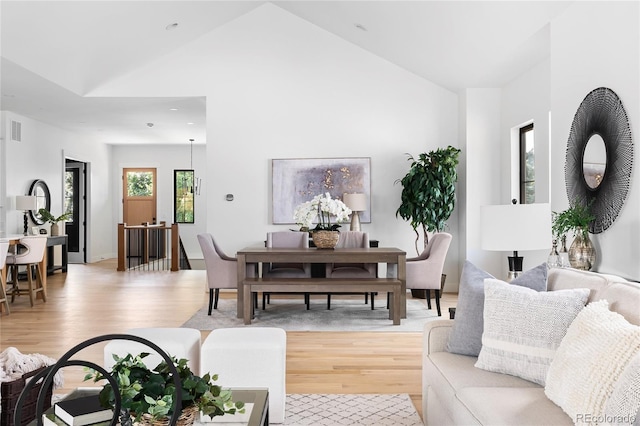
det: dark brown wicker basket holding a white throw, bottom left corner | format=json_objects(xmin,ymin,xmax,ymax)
[{"xmin": 0, "ymin": 367, "xmax": 53, "ymax": 426}]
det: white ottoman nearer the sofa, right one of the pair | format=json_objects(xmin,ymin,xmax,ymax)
[{"xmin": 200, "ymin": 327, "xmax": 287, "ymax": 423}]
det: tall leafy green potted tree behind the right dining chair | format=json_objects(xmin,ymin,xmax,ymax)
[{"xmin": 396, "ymin": 145, "xmax": 460, "ymax": 298}]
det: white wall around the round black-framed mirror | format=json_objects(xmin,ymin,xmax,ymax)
[{"xmin": 551, "ymin": 2, "xmax": 640, "ymax": 280}]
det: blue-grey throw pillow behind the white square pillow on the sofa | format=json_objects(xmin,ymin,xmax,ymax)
[{"xmin": 447, "ymin": 261, "xmax": 547, "ymax": 356}]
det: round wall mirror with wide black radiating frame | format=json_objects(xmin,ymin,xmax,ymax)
[{"xmin": 564, "ymin": 87, "xmax": 633, "ymax": 234}]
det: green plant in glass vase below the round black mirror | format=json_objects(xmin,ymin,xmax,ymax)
[{"xmin": 551, "ymin": 202, "xmax": 596, "ymax": 271}]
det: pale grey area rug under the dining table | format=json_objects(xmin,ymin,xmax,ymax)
[{"xmin": 182, "ymin": 296, "xmax": 442, "ymax": 332}]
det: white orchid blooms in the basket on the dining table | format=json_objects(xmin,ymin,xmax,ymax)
[{"xmin": 293, "ymin": 192, "xmax": 351, "ymax": 231}]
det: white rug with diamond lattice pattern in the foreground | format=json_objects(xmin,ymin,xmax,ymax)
[{"xmin": 284, "ymin": 394, "xmax": 423, "ymax": 426}]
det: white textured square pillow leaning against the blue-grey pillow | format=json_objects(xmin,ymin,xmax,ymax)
[{"xmin": 475, "ymin": 278, "xmax": 589, "ymax": 386}]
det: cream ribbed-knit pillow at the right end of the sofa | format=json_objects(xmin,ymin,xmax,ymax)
[{"xmin": 544, "ymin": 300, "xmax": 640, "ymax": 424}]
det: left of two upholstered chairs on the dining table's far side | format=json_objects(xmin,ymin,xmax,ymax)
[{"xmin": 262, "ymin": 231, "xmax": 311, "ymax": 310}]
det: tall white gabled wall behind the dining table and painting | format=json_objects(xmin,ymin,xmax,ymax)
[{"xmin": 92, "ymin": 4, "xmax": 459, "ymax": 285}]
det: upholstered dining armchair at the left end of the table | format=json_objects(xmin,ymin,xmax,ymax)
[{"xmin": 198, "ymin": 234, "xmax": 256, "ymax": 315}]
